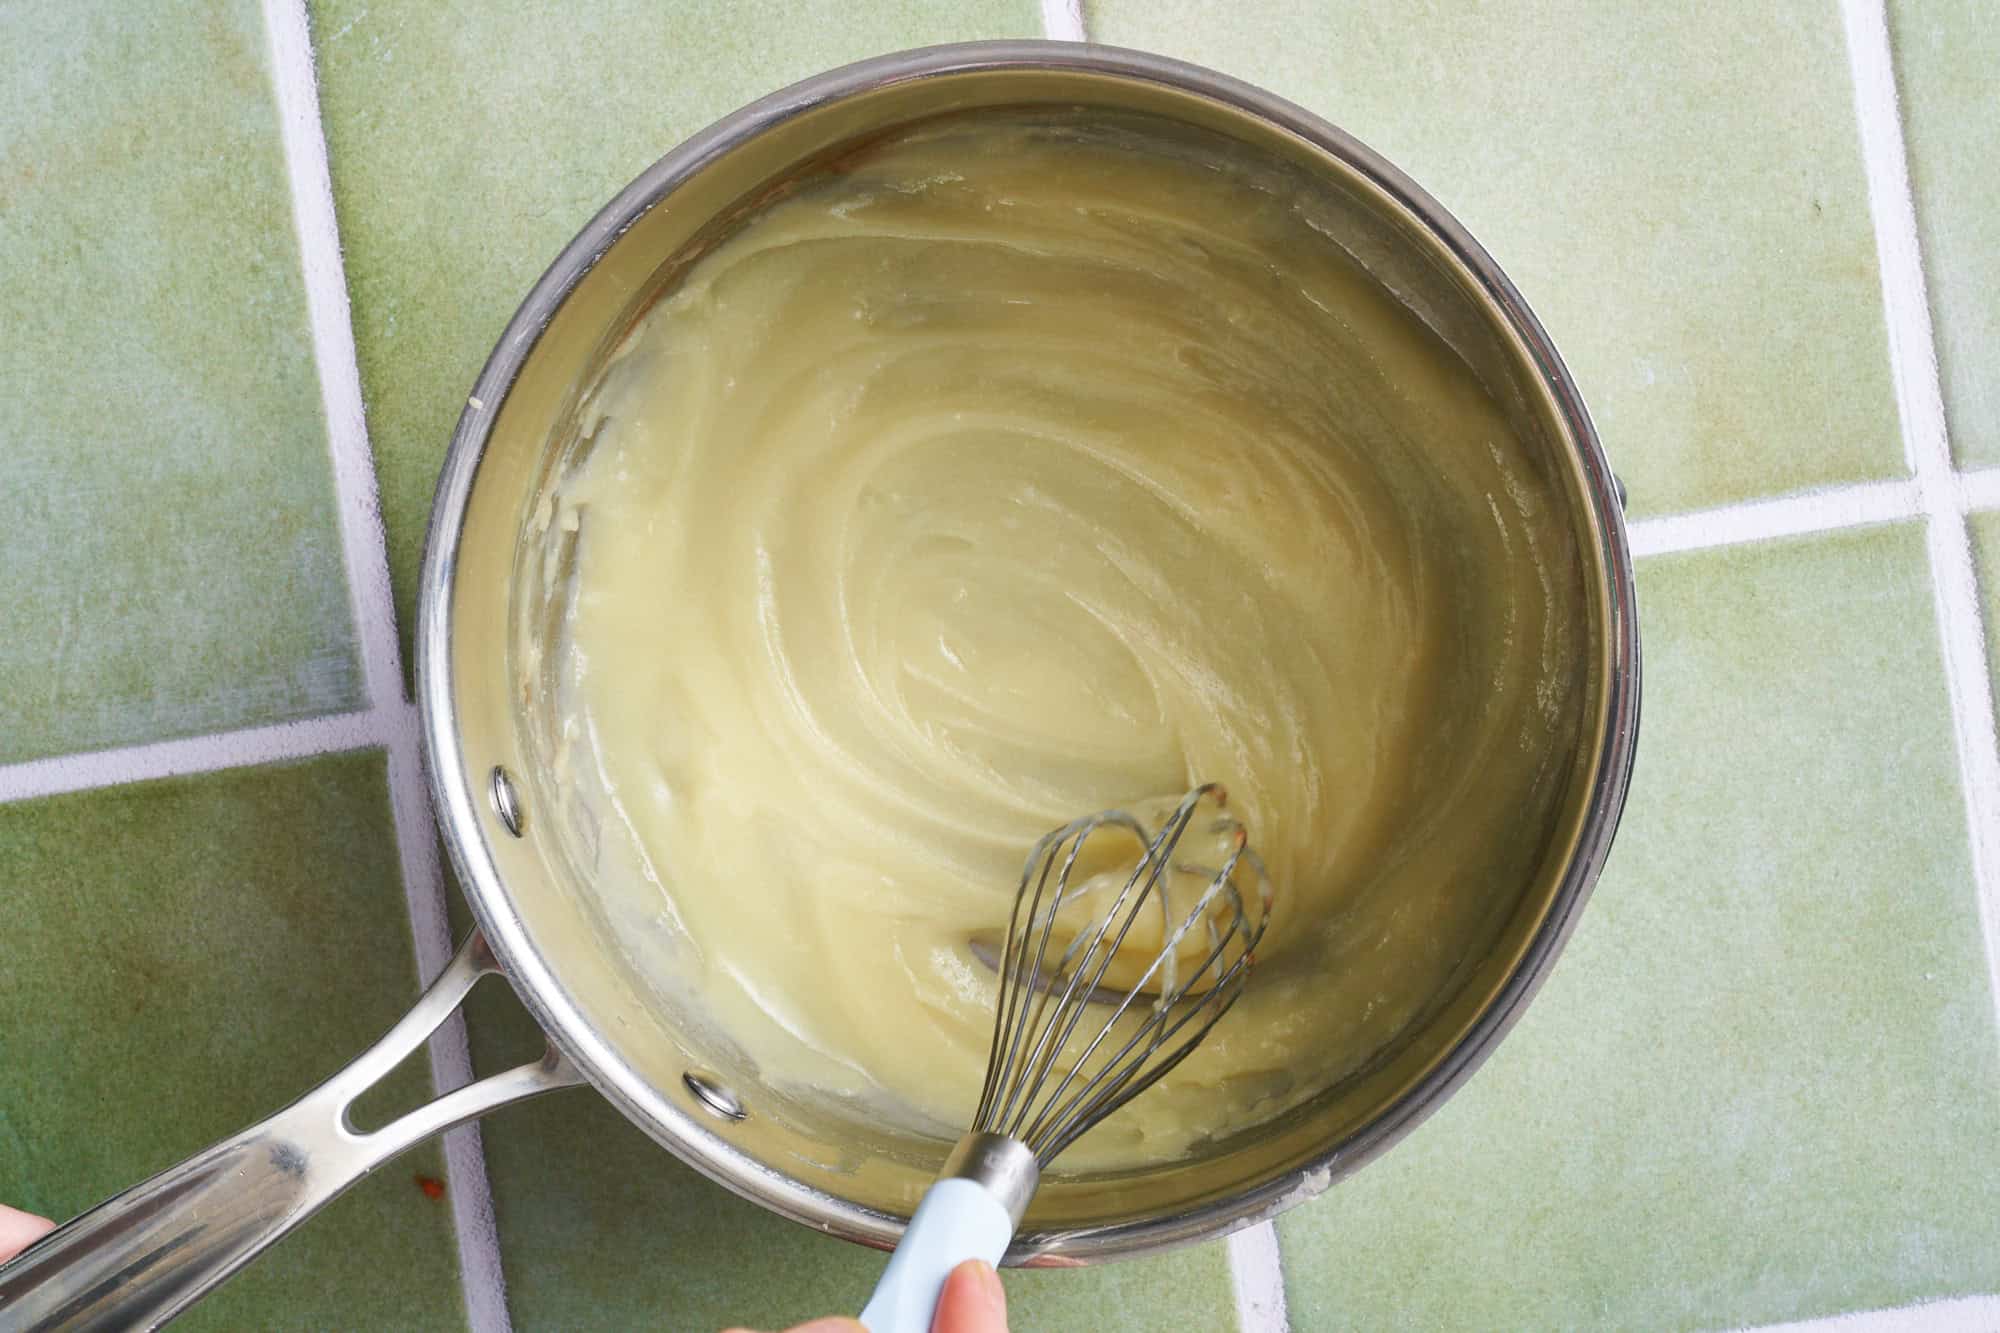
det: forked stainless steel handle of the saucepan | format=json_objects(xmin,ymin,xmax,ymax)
[{"xmin": 0, "ymin": 931, "xmax": 582, "ymax": 1329}]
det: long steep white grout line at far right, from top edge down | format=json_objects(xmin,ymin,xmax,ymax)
[{"xmin": 1840, "ymin": 0, "xmax": 2000, "ymax": 1064}]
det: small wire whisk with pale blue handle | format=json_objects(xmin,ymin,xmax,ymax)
[{"xmin": 862, "ymin": 783, "xmax": 1272, "ymax": 1333}]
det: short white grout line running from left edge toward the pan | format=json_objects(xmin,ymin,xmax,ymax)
[{"xmin": 0, "ymin": 711, "xmax": 386, "ymax": 803}]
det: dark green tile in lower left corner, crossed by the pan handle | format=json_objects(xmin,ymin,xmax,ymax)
[{"xmin": 0, "ymin": 753, "xmax": 464, "ymax": 1329}]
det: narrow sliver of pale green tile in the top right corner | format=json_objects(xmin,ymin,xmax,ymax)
[{"xmin": 1888, "ymin": 0, "xmax": 2000, "ymax": 464}]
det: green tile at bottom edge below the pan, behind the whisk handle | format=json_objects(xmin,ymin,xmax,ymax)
[{"xmin": 452, "ymin": 876, "xmax": 1236, "ymax": 1333}]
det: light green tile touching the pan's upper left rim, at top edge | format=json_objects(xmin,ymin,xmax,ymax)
[{"xmin": 312, "ymin": 0, "xmax": 1040, "ymax": 664}]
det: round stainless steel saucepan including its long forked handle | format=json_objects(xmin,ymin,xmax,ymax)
[{"xmin": 0, "ymin": 42, "xmax": 1640, "ymax": 1329}]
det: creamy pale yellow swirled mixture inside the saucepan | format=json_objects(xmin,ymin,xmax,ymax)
[{"xmin": 556, "ymin": 118, "xmax": 1584, "ymax": 1165}]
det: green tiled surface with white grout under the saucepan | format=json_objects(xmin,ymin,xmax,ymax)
[{"xmin": 0, "ymin": 0, "xmax": 2000, "ymax": 1333}]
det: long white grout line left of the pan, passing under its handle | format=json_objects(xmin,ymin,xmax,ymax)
[{"xmin": 264, "ymin": 0, "xmax": 510, "ymax": 1333}]
